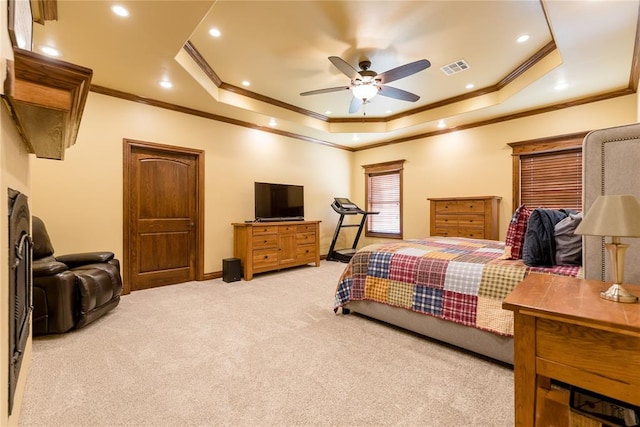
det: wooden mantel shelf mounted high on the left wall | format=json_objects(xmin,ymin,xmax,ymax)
[{"xmin": 4, "ymin": 47, "xmax": 93, "ymax": 160}]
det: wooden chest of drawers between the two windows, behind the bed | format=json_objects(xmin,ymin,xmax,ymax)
[{"xmin": 429, "ymin": 196, "xmax": 502, "ymax": 240}]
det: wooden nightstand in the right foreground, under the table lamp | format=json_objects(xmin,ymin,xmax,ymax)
[{"xmin": 502, "ymin": 274, "xmax": 640, "ymax": 426}]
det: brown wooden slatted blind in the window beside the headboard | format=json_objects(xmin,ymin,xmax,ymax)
[{"xmin": 520, "ymin": 149, "xmax": 582, "ymax": 211}]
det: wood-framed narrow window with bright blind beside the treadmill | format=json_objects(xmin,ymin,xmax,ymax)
[{"xmin": 363, "ymin": 160, "xmax": 404, "ymax": 239}]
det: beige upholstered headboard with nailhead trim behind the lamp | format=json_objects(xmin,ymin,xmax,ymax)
[{"xmin": 582, "ymin": 124, "xmax": 640, "ymax": 283}]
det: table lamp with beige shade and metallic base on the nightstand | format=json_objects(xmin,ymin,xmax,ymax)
[{"xmin": 575, "ymin": 194, "xmax": 640, "ymax": 303}]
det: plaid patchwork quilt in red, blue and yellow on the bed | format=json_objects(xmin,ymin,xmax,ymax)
[{"xmin": 334, "ymin": 237, "xmax": 582, "ymax": 336}]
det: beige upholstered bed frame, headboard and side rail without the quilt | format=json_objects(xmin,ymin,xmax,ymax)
[{"xmin": 343, "ymin": 124, "xmax": 640, "ymax": 364}]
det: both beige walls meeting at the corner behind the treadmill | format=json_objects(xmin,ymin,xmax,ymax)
[{"xmin": 32, "ymin": 93, "xmax": 637, "ymax": 273}]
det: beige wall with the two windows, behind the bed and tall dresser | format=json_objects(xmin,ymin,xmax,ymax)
[{"xmin": 351, "ymin": 95, "xmax": 637, "ymax": 246}]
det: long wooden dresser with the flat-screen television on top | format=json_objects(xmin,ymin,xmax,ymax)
[{"xmin": 232, "ymin": 221, "xmax": 320, "ymax": 280}]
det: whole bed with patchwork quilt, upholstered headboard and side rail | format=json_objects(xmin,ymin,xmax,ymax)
[{"xmin": 334, "ymin": 124, "xmax": 640, "ymax": 364}]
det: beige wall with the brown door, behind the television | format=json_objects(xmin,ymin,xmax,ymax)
[{"xmin": 32, "ymin": 93, "xmax": 351, "ymax": 273}]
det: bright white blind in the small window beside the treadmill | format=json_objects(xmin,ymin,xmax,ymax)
[{"xmin": 367, "ymin": 171, "xmax": 400, "ymax": 234}]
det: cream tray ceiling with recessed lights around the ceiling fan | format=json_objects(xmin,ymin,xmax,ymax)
[{"xmin": 34, "ymin": 0, "xmax": 638, "ymax": 148}]
